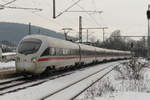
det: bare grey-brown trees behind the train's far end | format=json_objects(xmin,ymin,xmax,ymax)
[{"xmin": 94, "ymin": 30, "xmax": 147, "ymax": 57}]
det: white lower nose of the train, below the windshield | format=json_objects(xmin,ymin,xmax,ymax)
[{"xmin": 16, "ymin": 58, "xmax": 36, "ymax": 73}]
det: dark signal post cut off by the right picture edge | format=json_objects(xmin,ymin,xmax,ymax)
[{"xmin": 147, "ymin": 5, "xmax": 150, "ymax": 57}]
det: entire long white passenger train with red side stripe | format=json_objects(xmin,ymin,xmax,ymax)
[{"xmin": 16, "ymin": 35, "xmax": 131, "ymax": 74}]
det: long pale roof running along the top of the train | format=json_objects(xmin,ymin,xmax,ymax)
[{"xmin": 21, "ymin": 34, "xmax": 130, "ymax": 53}]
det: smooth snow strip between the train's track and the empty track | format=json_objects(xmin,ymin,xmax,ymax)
[{"xmin": 0, "ymin": 62, "xmax": 125, "ymax": 100}]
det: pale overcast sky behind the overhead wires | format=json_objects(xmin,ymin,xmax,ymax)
[{"xmin": 0, "ymin": 0, "xmax": 150, "ymax": 40}]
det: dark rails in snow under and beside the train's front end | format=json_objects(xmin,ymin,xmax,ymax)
[{"xmin": 0, "ymin": 69, "xmax": 74, "ymax": 96}]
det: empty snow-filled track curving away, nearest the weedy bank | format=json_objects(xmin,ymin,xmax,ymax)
[{"xmin": 41, "ymin": 64, "xmax": 119, "ymax": 100}]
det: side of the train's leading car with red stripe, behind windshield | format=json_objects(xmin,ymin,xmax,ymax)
[{"xmin": 38, "ymin": 38, "xmax": 80, "ymax": 68}]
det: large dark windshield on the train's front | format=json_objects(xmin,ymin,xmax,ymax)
[{"xmin": 18, "ymin": 38, "xmax": 42, "ymax": 55}]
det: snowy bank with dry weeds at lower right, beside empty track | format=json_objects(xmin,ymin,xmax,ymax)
[{"xmin": 76, "ymin": 58, "xmax": 150, "ymax": 100}]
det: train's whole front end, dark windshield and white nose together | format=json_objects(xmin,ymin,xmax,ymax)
[{"xmin": 16, "ymin": 36, "xmax": 42, "ymax": 74}]
